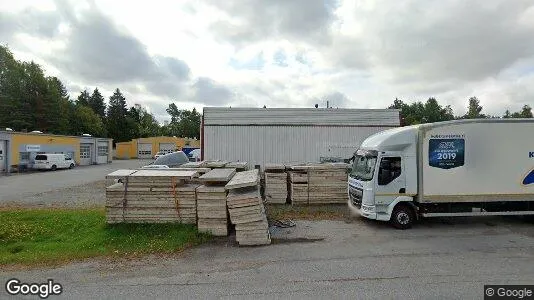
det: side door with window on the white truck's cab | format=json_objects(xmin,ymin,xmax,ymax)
[{"xmin": 375, "ymin": 156, "xmax": 406, "ymax": 205}]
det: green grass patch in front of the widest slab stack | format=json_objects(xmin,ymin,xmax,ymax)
[{"xmin": 0, "ymin": 209, "xmax": 214, "ymax": 265}]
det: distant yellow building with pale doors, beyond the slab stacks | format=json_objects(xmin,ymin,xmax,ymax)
[{"xmin": 115, "ymin": 136, "xmax": 200, "ymax": 159}]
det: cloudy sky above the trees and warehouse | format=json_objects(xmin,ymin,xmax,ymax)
[{"xmin": 0, "ymin": 0, "xmax": 534, "ymax": 120}]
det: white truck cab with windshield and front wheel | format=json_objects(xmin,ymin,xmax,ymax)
[{"xmin": 348, "ymin": 126, "xmax": 417, "ymax": 229}]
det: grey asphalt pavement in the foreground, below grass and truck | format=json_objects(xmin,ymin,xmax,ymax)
[{"xmin": 0, "ymin": 217, "xmax": 534, "ymax": 299}]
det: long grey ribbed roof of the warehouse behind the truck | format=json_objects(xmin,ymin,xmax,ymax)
[{"xmin": 203, "ymin": 107, "xmax": 400, "ymax": 126}]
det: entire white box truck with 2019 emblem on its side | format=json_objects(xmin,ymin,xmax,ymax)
[{"xmin": 348, "ymin": 119, "xmax": 534, "ymax": 229}]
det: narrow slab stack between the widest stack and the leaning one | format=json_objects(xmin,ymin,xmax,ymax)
[{"xmin": 196, "ymin": 169, "xmax": 236, "ymax": 236}]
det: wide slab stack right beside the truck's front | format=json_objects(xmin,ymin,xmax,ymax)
[{"xmin": 289, "ymin": 163, "xmax": 349, "ymax": 205}]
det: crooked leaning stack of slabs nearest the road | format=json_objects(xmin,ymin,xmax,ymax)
[{"xmin": 225, "ymin": 170, "xmax": 271, "ymax": 246}]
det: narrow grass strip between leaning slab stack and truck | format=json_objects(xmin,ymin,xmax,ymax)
[{"xmin": 266, "ymin": 204, "xmax": 350, "ymax": 221}]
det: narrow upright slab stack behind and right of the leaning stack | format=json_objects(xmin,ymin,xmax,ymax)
[{"xmin": 264, "ymin": 164, "xmax": 287, "ymax": 204}]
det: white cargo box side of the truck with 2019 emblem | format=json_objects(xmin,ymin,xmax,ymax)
[{"xmin": 419, "ymin": 120, "xmax": 534, "ymax": 203}]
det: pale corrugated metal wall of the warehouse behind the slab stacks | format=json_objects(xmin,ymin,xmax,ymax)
[{"xmin": 204, "ymin": 126, "xmax": 392, "ymax": 166}]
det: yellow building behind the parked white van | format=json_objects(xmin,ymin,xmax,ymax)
[{"xmin": 0, "ymin": 131, "xmax": 113, "ymax": 172}]
